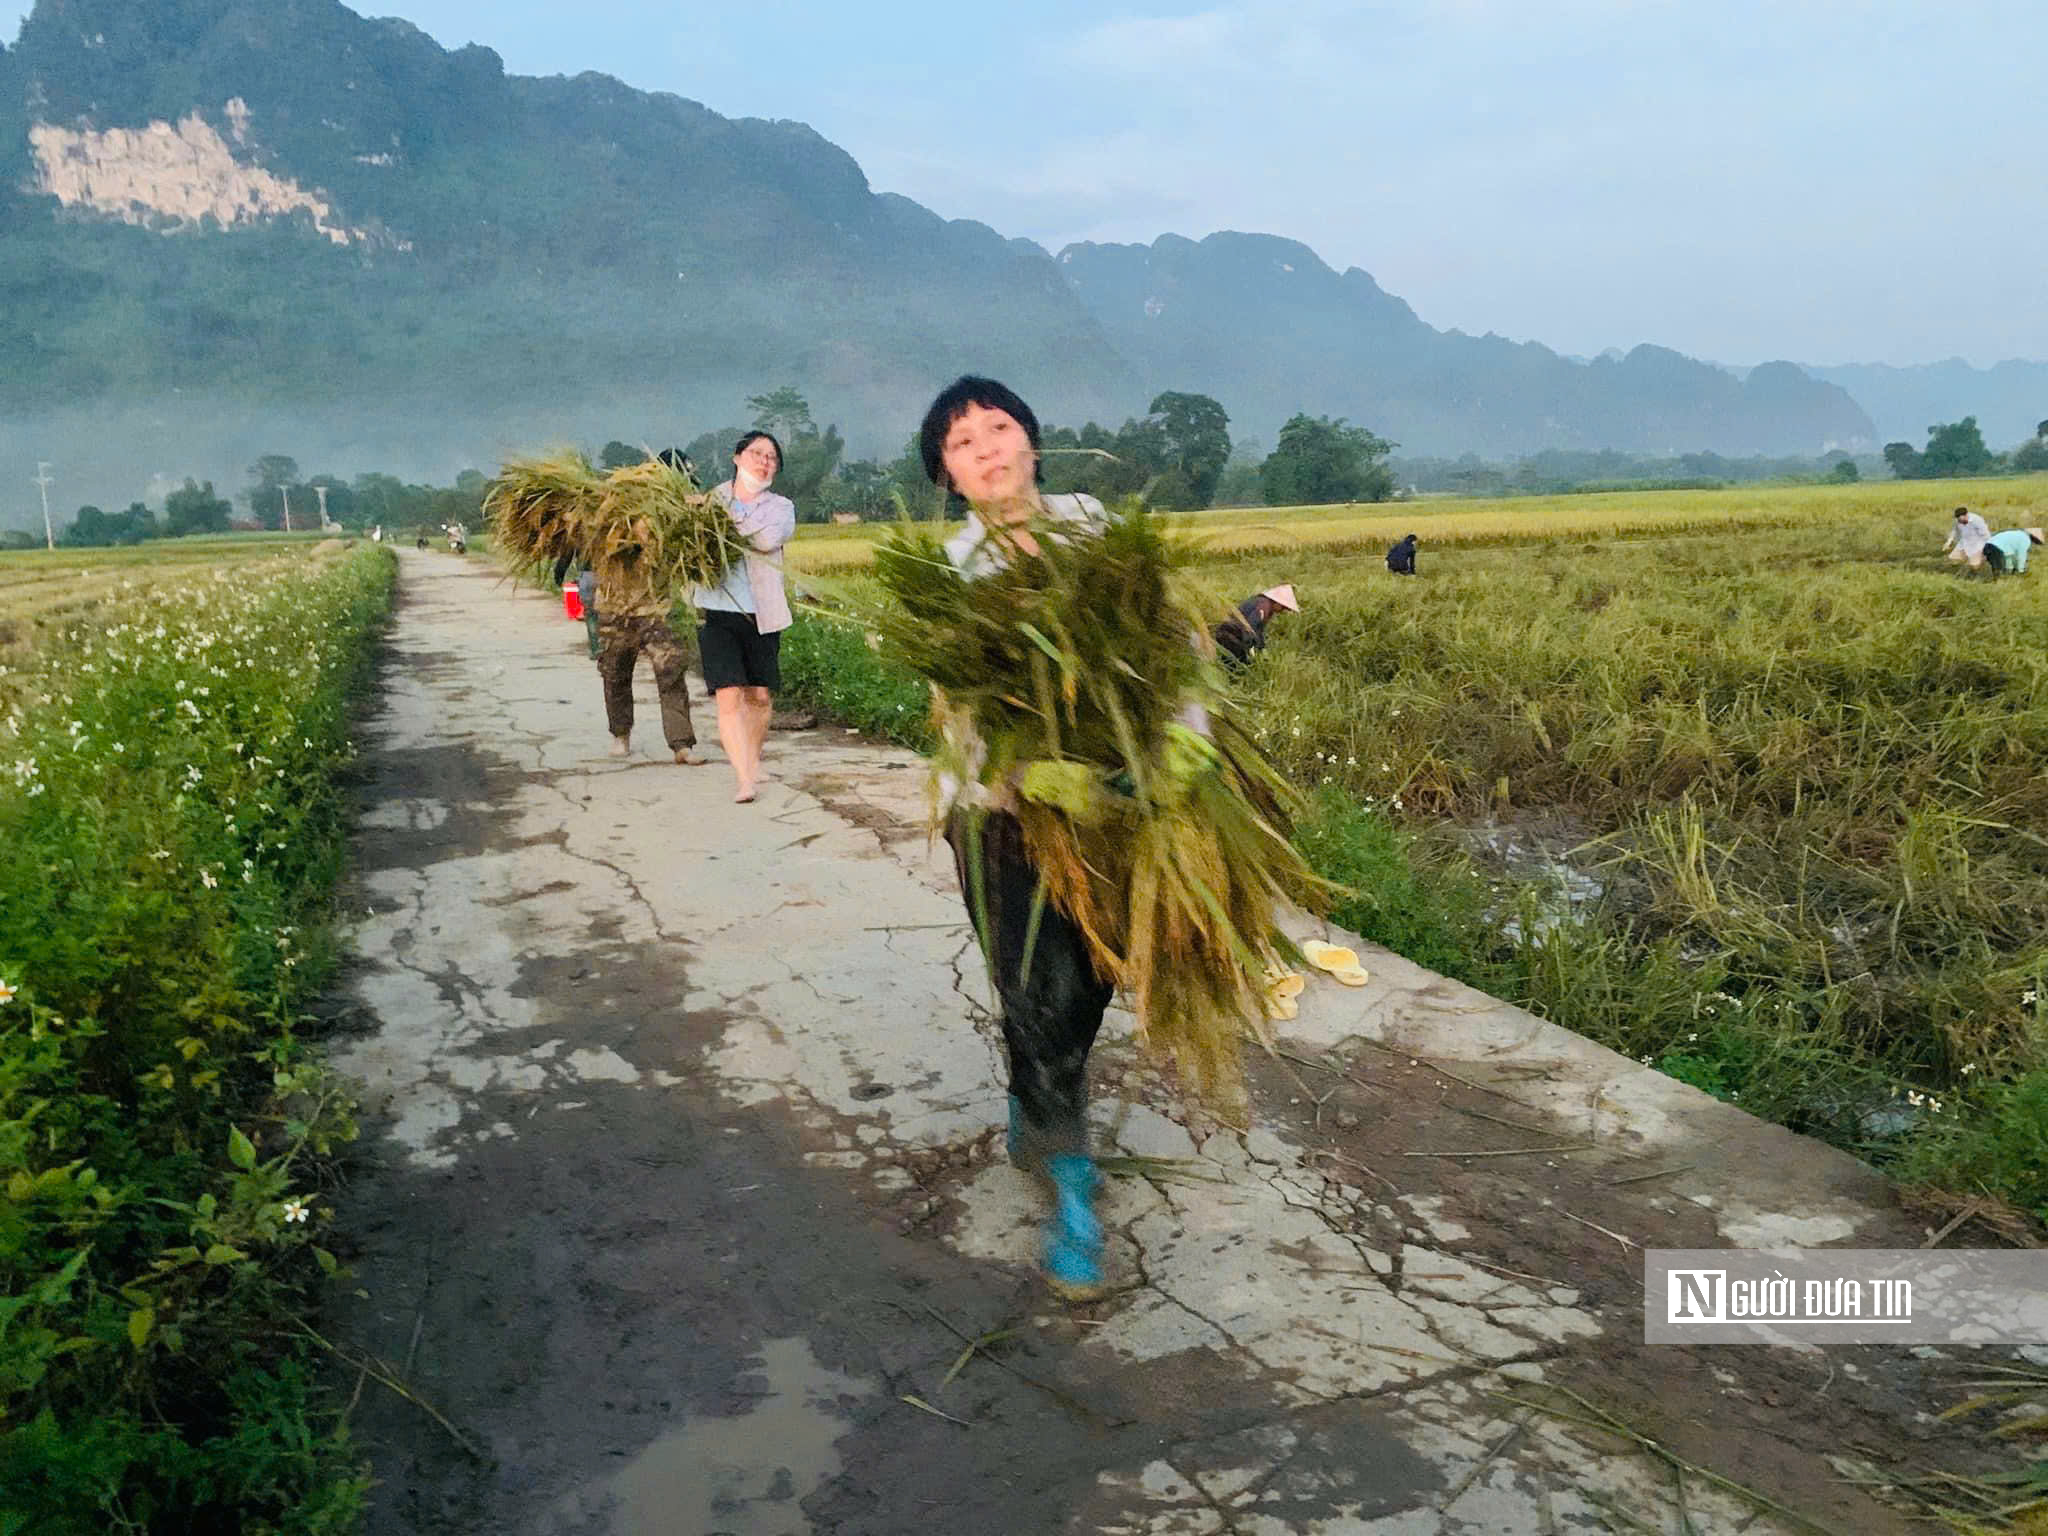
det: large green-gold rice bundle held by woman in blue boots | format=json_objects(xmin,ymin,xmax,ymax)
[{"xmin": 874, "ymin": 508, "xmax": 1329, "ymax": 1120}]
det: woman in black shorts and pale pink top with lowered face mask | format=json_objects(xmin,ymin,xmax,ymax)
[{"xmin": 690, "ymin": 432, "xmax": 797, "ymax": 805}]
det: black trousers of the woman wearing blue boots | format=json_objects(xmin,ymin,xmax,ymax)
[{"xmin": 946, "ymin": 811, "xmax": 1116, "ymax": 1167}]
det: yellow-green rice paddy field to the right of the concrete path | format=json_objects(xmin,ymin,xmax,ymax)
[{"xmin": 791, "ymin": 477, "xmax": 2048, "ymax": 1225}]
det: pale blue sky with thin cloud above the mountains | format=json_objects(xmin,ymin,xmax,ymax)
[{"xmin": 0, "ymin": 0, "xmax": 2048, "ymax": 365}]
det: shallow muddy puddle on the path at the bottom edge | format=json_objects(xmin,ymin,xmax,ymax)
[{"xmin": 612, "ymin": 1339, "xmax": 877, "ymax": 1536}]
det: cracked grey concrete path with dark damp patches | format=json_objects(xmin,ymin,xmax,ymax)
[{"xmin": 334, "ymin": 551, "xmax": 1982, "ymax": 1536}]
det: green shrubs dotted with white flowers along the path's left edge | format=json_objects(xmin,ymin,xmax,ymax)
[{"xmin": 0, "ymin": 543, "xmax": 395, "ymax": 1536}]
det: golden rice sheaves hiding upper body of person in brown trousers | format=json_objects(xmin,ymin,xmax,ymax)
[{"xmin": 483, "ymin": 453, "xmax": 748, "ymax": 596}]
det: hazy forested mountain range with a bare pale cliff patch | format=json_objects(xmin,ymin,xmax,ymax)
[{"xmin": 0, "ymin": 0, "xmax": 1878, "ymax": 522}]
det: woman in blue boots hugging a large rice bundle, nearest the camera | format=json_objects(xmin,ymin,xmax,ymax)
[{"xmin": 901, "ymin": 377, "xmax": 1317, "ymax": 1296}]
